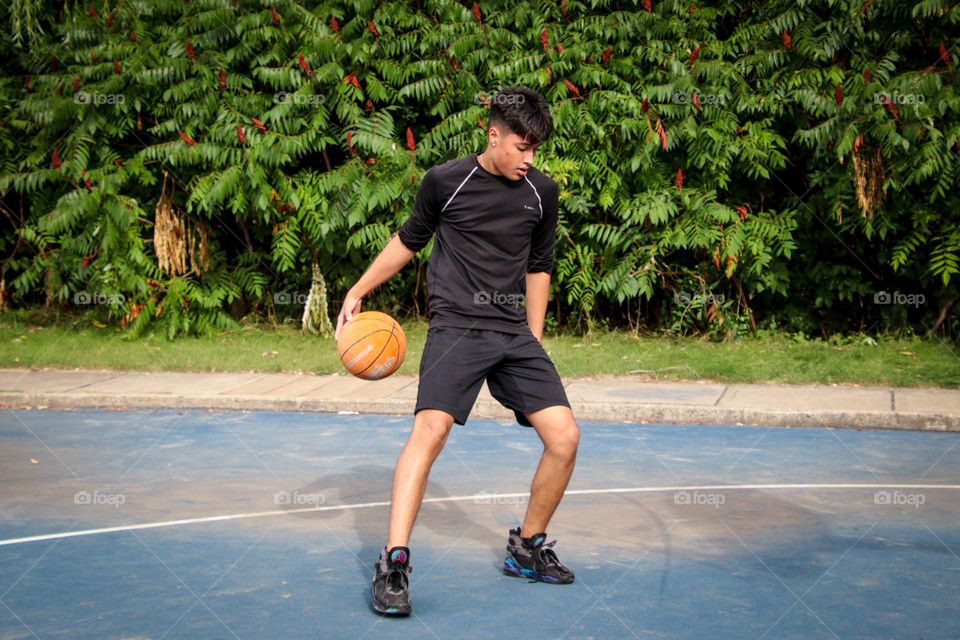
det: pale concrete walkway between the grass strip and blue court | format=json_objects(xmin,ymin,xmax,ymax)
[{"xmin": 0, "ymin": 369, "xmax": 960, "ymax": 431}]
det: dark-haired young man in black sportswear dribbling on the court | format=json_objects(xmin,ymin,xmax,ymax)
[{"xmin": 337, "ymin": 88, "xmax": 579, "ymax": 615}]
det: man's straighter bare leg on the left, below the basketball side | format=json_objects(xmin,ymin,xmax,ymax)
[{"xmin": 387, "ymin": 409, "xmax": 453, "ymax": 549}]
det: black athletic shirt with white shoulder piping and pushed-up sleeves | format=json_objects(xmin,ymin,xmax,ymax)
[{"xmin": 399, "ymin": 153, "xmax": 559, "ymax": 333}]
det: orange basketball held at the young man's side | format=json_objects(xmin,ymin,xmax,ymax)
[{"xmin": 337, "ymin": 311, "xmax": 407, "ymax": 380}]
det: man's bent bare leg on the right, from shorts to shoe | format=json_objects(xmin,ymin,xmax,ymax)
[{"xmin": 520, "ymin": 406, "xmax": 580, "ymax": 538}]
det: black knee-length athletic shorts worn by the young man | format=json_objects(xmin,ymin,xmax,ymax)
[{"xmin": 414, "ymin": 327, "xmax": 570, "ymax": 427}]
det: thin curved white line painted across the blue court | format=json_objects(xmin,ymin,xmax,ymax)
[{"xmin": 0, "ymin": 484, "xmax": 960, "ymax": 547}]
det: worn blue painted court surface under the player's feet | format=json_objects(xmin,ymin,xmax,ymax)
[{"xmin": 0, "ymin": 410, "xmax": 960, "ymax": 640}]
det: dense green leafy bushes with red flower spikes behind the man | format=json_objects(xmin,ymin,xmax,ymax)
[{"xmin": 0, "ymin": 0, "xmax": 960, "ymax": 336}]
